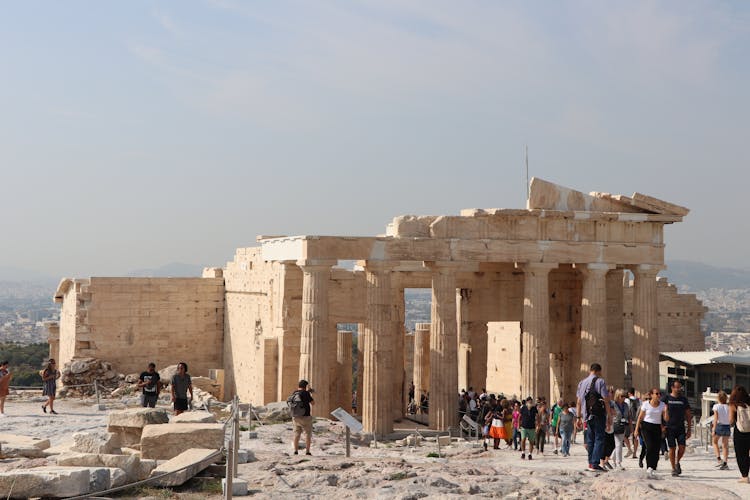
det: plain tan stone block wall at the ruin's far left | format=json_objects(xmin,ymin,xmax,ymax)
[{"xmin": 55, "ymin": 278, "xmax": 224, "ymax": 376}]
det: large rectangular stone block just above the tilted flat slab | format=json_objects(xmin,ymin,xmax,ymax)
[{"xmin": 141, "ymin": 424, "xmax": 224, "ymax": 460}]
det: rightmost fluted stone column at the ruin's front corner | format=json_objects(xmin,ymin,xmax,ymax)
[{"xmin": 632, "ymin": 264, "xmax": 661, "ymax": 393}]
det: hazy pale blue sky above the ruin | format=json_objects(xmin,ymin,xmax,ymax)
[{"xmin": 0, "ymin": 0, "xmax": 750, "ymax": 276}]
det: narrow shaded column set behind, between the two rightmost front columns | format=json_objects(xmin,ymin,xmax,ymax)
[{"xmin": 605, "ymin": 269, "xmax": 625, "ymax": 387}]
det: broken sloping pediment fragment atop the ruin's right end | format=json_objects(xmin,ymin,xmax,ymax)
[{"xmin": 526, "ymin": 177, "xmax": 690, "ymax": 217}]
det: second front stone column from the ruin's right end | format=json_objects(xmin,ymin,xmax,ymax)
[{"xmin": 578, "ymin": 264, "xmax": 613, "ymax": 380}]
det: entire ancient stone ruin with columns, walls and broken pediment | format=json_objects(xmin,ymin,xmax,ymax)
[{"xmin": 50, "ymin": 179, "xmax": 705, "ymax": 435}]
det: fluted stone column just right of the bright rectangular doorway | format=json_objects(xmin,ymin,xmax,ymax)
[{"xmin": 521, "ymin": 263, "xmax": 557, "ymax": 401}]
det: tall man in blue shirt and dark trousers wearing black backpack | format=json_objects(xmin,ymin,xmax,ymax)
[{"xmin": 576, "ymin": 363, "xmax": 612, "ymax": 472}]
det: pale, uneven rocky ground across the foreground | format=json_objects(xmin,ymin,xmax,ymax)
[{"xmin": 0, "ymin": 397, "xmax": 750, "ymax": 499}]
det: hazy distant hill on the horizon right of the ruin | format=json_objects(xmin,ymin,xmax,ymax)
[{"xmin": 661, "ymin": 260, "xmax": 750, "ymax": 290}]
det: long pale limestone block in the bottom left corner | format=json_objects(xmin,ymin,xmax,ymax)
[{"xmin": 0, "ymin": 467, "xmax": 90, "ymax": 498}]
